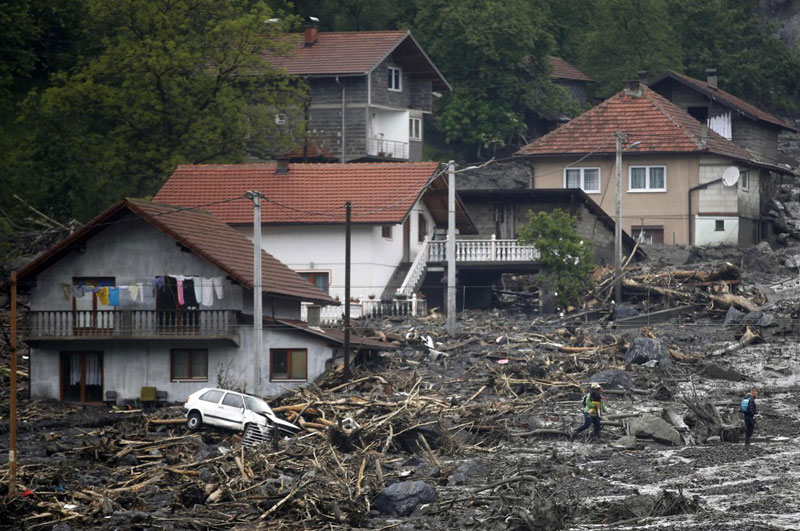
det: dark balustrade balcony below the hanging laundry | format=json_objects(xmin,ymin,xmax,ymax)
[{"xmin": 20, "ymin": 310, "xmax": 239, "ymax": 345}]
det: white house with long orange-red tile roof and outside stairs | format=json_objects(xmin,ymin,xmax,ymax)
[{"xmin": 155, "ymin": 162, "xmax": 476, "ymax": 300}]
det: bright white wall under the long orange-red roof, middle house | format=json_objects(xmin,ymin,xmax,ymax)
[{"xmin": 242, "ymin": 201, "xmax": 435, "ymax": 300}]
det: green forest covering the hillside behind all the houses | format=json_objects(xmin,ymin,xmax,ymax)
[{"xmin": 0, "ymin": 0, "xmax": 800, "ymax": 249}]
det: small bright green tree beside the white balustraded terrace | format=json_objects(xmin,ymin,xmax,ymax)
[{"xmin": 519, "ymin": 210, "xmax": 594, "ymax": 307}]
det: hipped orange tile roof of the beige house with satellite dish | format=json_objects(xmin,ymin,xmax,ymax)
[{"xmin": 517, "ymin": 85, "xmax": 753, "ymax": 161}]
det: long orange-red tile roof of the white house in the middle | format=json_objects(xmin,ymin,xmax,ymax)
[{"xmin": 154, "ymin": 162, "xmax": 439, "ymax": 224}]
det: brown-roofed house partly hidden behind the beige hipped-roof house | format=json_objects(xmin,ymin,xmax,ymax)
[{"xmin": 648, "ymin": 69, "xmax": 797, "ymax": 164}]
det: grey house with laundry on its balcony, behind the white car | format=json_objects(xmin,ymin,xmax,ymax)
[{"xmin": 18, "ymin": 200, "xmax": 390, "ymax": 402}]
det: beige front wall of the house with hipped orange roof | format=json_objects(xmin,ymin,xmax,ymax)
[{"xmin": 529, "ymin": 154, "xmax": 699, "ymax": 245}]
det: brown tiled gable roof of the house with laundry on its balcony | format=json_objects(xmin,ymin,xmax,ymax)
[{"xmin": 19, "ymin": 199, "xmax": 334, "ymax": 304}]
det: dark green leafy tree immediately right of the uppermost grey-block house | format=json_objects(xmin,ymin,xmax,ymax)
[{"xmin": 414, "ymin": 0, "xmax": 571, "ymax": 158}]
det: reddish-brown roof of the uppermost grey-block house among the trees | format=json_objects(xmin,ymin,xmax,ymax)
[{"xmin": 262, "ymin": 31, "xmax": 450, "ymax": 90}]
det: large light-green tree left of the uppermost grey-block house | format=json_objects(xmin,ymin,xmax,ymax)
[{"xmin": 14, "ymin": 0, "xmax": 305, "ymax": 219}]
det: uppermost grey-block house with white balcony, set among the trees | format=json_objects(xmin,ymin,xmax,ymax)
[{"xmin": 264, "ymin": 23, "xmax": 450, "ymax": 162}]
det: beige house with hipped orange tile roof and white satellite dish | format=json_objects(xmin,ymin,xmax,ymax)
[{"xmin": 517, "ymin": 82, "xmax": 789, "ymax": 245}]
